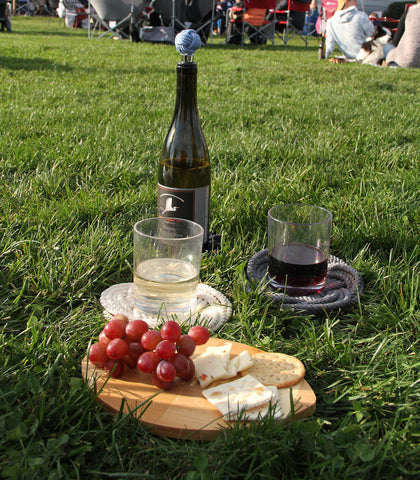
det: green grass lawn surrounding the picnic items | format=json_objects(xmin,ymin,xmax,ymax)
[{"xmin": 0, "ymin": 17, "xmax": 420, "ymax": 480}]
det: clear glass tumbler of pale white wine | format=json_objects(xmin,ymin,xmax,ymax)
[{"xmin": 133, "ymin": 217, "xmax": 204, "ymax": 320}]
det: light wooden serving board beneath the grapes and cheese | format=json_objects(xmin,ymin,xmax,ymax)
[{"xmin": 82, "ymin": 338, "xmax": 316, "ymax": 440}]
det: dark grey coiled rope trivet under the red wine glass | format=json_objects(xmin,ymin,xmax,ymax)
[{"xmin": 246, "ymin": 250, "xmax": 363, "ymax": 314}]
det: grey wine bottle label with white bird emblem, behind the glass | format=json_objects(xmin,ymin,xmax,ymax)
[{"xmin": 158, "ymin": 183, "xmax": 210, "ymax": 243}]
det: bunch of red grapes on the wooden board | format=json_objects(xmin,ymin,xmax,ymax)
[{"xmin": 89, "ymin": 314, "xmax": 210, "ymax": 390}]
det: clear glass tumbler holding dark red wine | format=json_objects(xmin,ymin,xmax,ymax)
[{"xmin": 268, "ymin": 203, "xmax": 332, "ymax": 296}]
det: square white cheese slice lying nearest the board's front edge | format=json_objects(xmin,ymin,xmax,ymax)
[{"xmin": 202, "ymin": 375, "xmax": 273, "ymax": 416}]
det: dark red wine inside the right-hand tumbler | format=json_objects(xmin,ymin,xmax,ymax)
[{"xmin": 268, "ymin": 243, "xmax": 328, "ymax": 296}]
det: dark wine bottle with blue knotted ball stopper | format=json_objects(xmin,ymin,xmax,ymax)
[{"xmin": 158, "ymin": 30, "xmax": 210, "ymax": 246}]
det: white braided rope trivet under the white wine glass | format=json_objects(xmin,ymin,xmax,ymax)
[{"xmin": 99, "ymin": 283, "xmax": 232, "ymax": 331}]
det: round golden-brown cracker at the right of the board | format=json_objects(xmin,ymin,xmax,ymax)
[{"xmin": 245, "ymin": 352, "xmax": 305, "ymax": 388}]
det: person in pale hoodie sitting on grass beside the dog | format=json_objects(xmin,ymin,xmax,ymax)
[{"xmin": 325, "ymin": 0, "xmax": 374, "ymax": 59}]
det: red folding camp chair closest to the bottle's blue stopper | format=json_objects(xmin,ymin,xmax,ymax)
[{"xmin": 226, "ymin": 0, "xmax": 276, "ymax": 46}]
